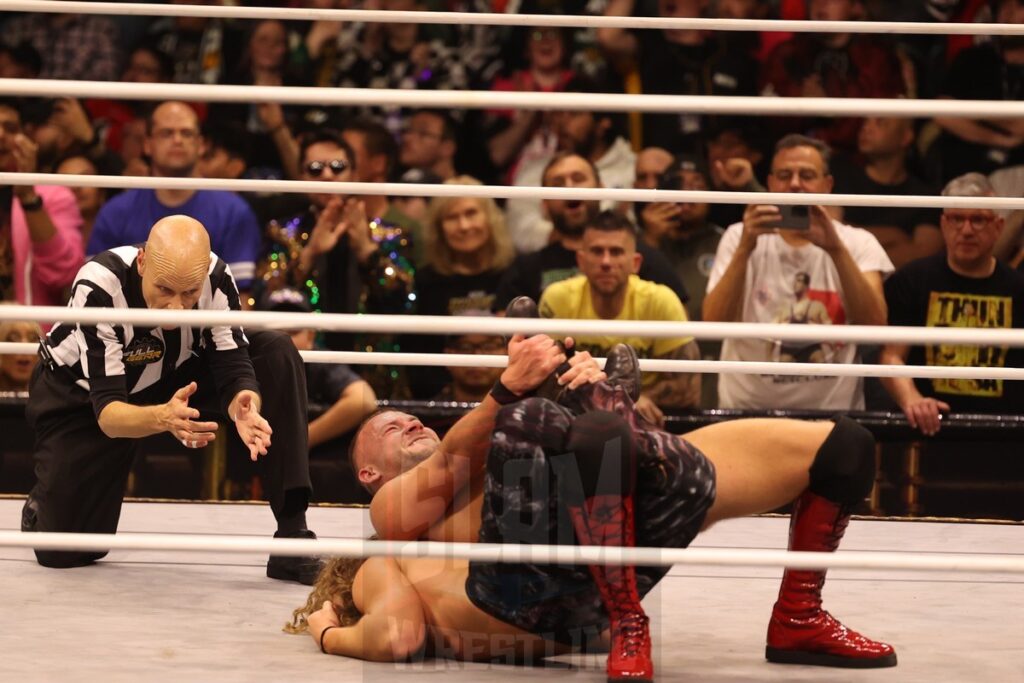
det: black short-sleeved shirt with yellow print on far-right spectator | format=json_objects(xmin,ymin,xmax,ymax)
[{"xmin": 885, "ymin": 252, "xmax": 1024, "ymax": 414}]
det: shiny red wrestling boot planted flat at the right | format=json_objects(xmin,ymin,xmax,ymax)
[{"xmin": 765, "ymin": 490, "xmax": 896, "ymax": 669}]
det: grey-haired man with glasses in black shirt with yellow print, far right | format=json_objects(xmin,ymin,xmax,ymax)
[{"xmin": 881, "ymin": 173, "xmax": 1024, "ymax": 435}]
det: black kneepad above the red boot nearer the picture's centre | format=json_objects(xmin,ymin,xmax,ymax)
[{"xmin": 562, "ymin": 411, "xmax": 636, "ymax": 498}]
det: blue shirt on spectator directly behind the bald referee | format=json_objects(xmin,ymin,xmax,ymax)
[{"xmin": 85, "ymin": 189, "xmax": 262, "ymax": 290}]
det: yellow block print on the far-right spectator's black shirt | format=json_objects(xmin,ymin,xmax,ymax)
[{"xmin": 925, "ymin": 292, "xmax": 1014, "ymax": 397}]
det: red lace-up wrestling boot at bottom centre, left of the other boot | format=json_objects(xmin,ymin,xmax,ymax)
[{"xmin": 568, "ymin": 494, "xmax": 654, "ymax": 683}]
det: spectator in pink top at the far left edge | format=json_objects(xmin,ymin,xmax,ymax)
[{"xmin": 0, "ymin": 99, "xmax": 83, "ymax": 306}]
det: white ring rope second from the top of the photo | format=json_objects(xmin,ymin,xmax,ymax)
[{"xmin": 0, "ymin": 78, "xmax": 1024, "ymax": 119}]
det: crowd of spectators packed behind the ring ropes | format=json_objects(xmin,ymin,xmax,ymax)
[{"xmin": 0, "ymin": 0, "xmax": 1024, "ymax": 454}]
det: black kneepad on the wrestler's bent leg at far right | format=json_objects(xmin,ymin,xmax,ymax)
[{"xmin": 810, "ymin": 415, "xmax": 874, "ymax": 505}]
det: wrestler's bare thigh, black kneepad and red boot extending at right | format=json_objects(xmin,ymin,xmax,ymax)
[{"xmin": 687, "ymin": 417, "xmax": 896, "ymax": 668}]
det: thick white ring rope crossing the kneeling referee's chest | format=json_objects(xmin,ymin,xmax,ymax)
[{"xmin": 0, "ymin": 306, "xmax": 1024, "ymax": 350}]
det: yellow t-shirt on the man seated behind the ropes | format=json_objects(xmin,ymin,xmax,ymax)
[{"xmin": 540, "ymin": 275, "xmax": 690, "ymax": 366}]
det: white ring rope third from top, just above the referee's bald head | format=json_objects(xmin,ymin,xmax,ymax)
[{"xmin": 0, "ymin": 172, "xmax": 1024, "ymax": 211}]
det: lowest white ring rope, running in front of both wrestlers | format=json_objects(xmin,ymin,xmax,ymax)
[{"xmin": 0, "ymin": 531, "xmax": 1024, "ymax": 573}]
